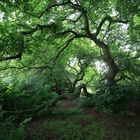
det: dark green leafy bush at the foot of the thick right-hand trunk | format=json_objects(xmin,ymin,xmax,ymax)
[{"xmin": 82, "ymin": 84, "xmax": 139, "ymax": 112}]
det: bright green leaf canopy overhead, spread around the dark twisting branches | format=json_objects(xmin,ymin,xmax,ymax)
[{"xmin": 0, "ymin": 0, "xmax": 139, "ymax": 86}]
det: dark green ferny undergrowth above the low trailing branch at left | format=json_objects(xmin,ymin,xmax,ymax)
[{"xmin": 0, "ymin": 80, "xmax": 58, "ymax": 117}]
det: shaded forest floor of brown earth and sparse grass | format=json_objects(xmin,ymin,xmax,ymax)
[{"xmin": 27, "ymin": 100, "xmax": 140, "ymax": 140}]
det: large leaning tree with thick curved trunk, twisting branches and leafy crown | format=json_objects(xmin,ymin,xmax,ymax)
[{"xmin": 0, "ymin": 0, "xmax": 139, "ymax": 87}]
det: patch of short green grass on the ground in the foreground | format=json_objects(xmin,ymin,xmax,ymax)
[{"xmin": 26, "ymin": 115, "xmax": 106, "ymax": 140}]
